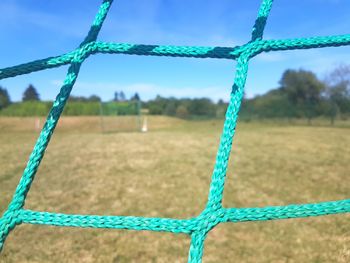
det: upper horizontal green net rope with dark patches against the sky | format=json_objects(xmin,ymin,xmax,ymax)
[{"xmin": 0, "ymin": 34, "xmax": 350, "ymax": 80}]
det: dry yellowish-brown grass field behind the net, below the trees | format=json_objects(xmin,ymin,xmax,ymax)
[{"xmin": 0, "ymin": 117, "xmax": 350, "ymax": 263}]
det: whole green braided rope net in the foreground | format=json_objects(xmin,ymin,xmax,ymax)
[{"xmin": 0, "ymin": 0, "xmax": 350, "ymax": 262}]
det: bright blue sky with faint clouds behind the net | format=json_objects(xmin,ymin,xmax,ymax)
[{"xmin": 0, "ymin": 0, "xmax": 350, "ymax": 101}]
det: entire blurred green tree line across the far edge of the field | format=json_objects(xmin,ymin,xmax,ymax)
[{"xmin": 0, "ymin": 65, "xmax": 350, "ymax": 123}]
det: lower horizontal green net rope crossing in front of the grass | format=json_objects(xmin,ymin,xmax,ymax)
[{"xmin": 18, "ymin": 200, "xmax": 350, "ymax": 234}]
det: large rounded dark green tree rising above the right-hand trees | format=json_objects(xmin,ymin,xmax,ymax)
[{"xmin": 280, "ymin": 69, "xmax": 325, "ymax": 124}]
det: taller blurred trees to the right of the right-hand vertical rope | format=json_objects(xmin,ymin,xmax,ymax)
[{"xmin": 241, "ymin": 65, "xmax": 350, "ymax": 124}]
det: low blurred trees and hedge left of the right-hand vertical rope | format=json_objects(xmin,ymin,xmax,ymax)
[{"xmin": 0, "ymin": 84, "xmax": 227, "ymax": 118}]
